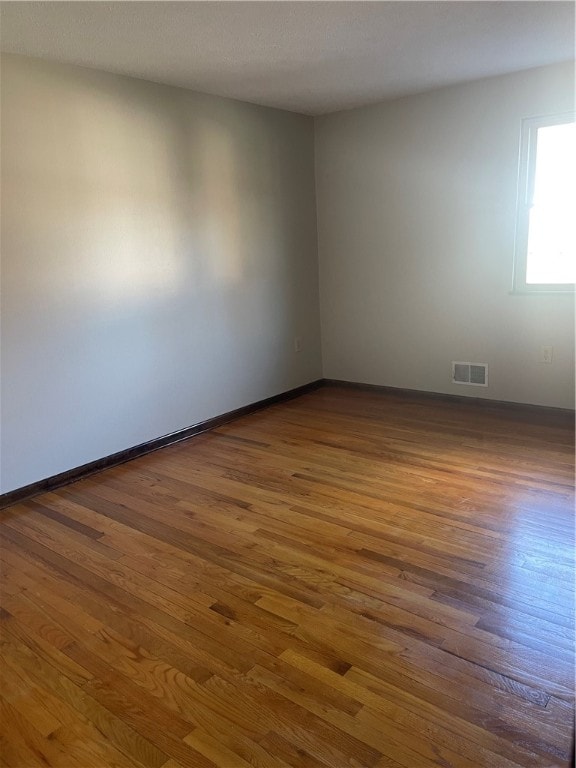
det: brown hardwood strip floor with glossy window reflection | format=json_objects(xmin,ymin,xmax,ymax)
[{"xmin": 0, "ymin": 387, "xmax": 574, "ymax": 768}]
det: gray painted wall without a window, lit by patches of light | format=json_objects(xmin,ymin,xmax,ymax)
[{"xmin": 1, "ymin": 55, "xmax": 321, "ymax": 492}]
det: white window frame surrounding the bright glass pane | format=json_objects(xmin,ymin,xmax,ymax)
[{"xmin": 512, "ymin": 112, "xmax": 576, "ymax": 294}]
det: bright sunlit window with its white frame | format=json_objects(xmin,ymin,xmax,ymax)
[{"xmin": 514, "ymin": 114, "xmax": 576, "ymax": 293}]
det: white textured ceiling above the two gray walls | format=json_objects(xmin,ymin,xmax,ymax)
[{"xmin": 0, "ymin": 0, "xmax": 574, "ymax": 115}]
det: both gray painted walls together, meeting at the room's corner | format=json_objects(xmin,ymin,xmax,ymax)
[{"xmin": 1, "ymin": 55, "xmax": 574, "ymax": 492}]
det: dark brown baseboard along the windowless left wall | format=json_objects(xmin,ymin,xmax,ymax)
[{"xmin": 0, "ymin": 379, "xmax": 324, "ymax": 509}]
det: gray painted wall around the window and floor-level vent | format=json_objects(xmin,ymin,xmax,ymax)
[{"xmin": 315, "ymin": 64, "xmax": 574, "ymax": 408}]
